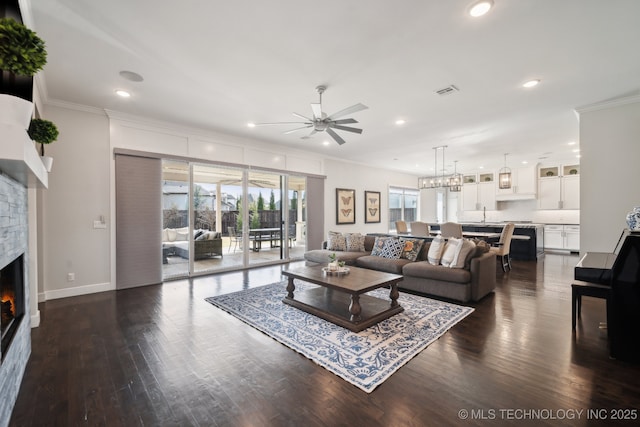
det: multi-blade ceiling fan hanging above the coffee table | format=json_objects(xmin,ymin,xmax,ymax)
[{"xmin": 255, "ymin": 86, "xmax": 369, "ymax": 145}]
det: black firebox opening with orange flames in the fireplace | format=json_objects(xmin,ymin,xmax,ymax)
[{"xmin": 0, "ymin": 255, "xmax": 25, "ymax": 358}]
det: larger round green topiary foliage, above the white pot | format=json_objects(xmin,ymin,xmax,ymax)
[{"xmin": 0, "ymin": 18, "xmax": 47, "ymax": 76}]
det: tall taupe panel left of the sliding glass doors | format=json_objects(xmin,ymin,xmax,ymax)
[{"xmin": 115, "ymin": 155, "xmax": 162, "ymax": 289}]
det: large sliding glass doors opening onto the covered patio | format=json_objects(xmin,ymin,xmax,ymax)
[{"xmin": 161, "ymin": 160, "xmax": 306, "ymax": 280}]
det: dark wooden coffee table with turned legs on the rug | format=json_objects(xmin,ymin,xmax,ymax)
[{"xmin": 282, "ymin": 265, "xmax": 404, "ymax": 332}]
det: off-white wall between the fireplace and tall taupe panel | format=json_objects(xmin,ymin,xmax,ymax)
[{"xmin": 38, "ymin": 106, "xmax": 111, "ymax": 300}]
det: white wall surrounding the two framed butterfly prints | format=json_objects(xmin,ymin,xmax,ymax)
[{"xmin": 324, "ymin": 159, "xmax": 418, "ymax": 235}]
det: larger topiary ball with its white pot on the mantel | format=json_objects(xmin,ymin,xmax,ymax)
[{"xmin": 0, "ymin": 18, "xmax": 47, "ymax": 129}]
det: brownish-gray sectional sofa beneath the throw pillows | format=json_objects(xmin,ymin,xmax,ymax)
[{"xmin": 304, "ymin": 235, "xmax": 496, "ymax": 302}]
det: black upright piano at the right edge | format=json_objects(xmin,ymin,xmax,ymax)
[{"xmin": 574, "ymin": 230, "xmax": 640, "ymax": 362}]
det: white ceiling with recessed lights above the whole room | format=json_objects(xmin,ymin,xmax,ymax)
[{"xmin": 21, "ymin": 0, "xmax": 640, "ymax": 174}]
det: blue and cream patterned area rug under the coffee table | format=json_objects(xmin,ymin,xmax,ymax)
[{"xmin": 206, "ymin": 281, "xmax": 473, "ymax": 393}]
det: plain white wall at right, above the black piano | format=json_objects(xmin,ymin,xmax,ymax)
[{"xmin": 578, "ymin": 96, "xmax": 640, "ymax": 252}]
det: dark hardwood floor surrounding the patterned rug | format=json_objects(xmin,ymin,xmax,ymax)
[{"xmin": 10, "ymin": 255, "xmax": 640, "ymax": 426}]
